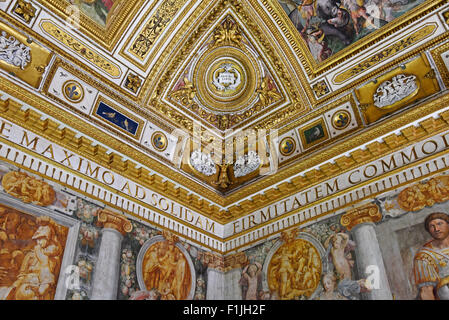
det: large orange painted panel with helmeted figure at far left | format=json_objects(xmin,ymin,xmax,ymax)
[{"xmin": 0, "ymin": 211, "xmax": 66, "ymax": 300}]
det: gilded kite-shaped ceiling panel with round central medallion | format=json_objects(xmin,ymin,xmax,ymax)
[{"xmin": 164, "ymin": 15, "xmax": 285, "ymax": 130}]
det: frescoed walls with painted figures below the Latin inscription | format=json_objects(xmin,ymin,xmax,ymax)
[{"xmin": 0, "ymin": 156, "xmax": 449, "ymax": 300}]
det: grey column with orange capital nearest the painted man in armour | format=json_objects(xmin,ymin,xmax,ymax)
[{"xmin": 340, "ymin": 204, "xmax": 393, "ymax": 300}]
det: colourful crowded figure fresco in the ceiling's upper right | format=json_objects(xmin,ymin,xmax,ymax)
[{"xmin": 279, "ymin": 0, "xmax": 425, "ymax": 63}]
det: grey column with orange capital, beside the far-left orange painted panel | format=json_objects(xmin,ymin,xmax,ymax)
[{"xmin": 91, "ymin": 210, "xmax": 132, "ymax": 300}]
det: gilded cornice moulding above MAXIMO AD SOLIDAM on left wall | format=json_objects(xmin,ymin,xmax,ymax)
[{"xmin": 0, "ymin": 84, "xmax": 228, "ymax": 215}]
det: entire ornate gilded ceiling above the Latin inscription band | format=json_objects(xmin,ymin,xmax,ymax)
[{"xmin": 0, "ymin": 0, "xmax": 449, "ymax": 252}]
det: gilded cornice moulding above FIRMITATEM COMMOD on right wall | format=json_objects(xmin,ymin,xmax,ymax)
[{"xmin": 227, "ymin": 95, "xmax": 449, "ymax": 218}]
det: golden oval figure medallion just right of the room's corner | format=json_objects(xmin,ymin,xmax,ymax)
[{"xmin": 267, "ymin": 239, "xmax": 322, "ymax": 300}]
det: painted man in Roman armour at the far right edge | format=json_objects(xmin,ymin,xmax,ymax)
[{"xmin": 414, "ymin": 212, "xmax": 449, "ymax": 300}]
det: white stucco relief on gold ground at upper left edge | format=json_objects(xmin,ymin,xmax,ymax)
[{"xmin": 0, "ymin": 31, "xmax": 31, "ymax": 70}]
